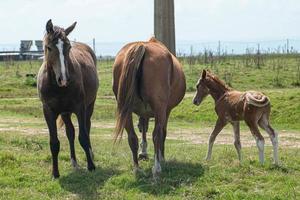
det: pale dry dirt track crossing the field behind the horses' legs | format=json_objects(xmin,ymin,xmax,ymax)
[{"xmin": 0, "ymin": 118, "xmax": 300, "ymax": 148}]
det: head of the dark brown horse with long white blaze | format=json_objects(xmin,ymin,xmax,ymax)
[{"xmin": 44, "ymin": 19, "xmax": 76, "ymax": 87}]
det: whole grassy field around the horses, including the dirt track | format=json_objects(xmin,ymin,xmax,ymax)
[{"xmin": 0, "ymin": 55, "xmax": 300, "ymax": 199}]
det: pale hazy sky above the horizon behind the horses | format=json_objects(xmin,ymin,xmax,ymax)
[{"xmin": 0, "ymin": 0, "xmax": 300, "ymax": 50}]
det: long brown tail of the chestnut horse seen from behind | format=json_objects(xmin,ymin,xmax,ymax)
[{"xmin": 114, "ymin": 43, "xmax": 145, "ymax": 142}]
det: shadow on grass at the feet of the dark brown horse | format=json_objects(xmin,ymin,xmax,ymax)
[{"xmin": 59, "ymin": 167, "xmax": 119, "ymax": 199}]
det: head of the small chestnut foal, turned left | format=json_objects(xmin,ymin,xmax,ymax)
[{"xmin": 193, "ymin": 69, "xmax": 209, "ymax": 106}]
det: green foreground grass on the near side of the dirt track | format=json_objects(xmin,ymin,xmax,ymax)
[{"xmin": 0, "ymin": 126, "xmax": 300, "ymax": 199}]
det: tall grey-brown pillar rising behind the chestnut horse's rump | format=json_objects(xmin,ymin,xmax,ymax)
[{"xmin": 154, "ymin": 0, "xmax": 176, "ymax": 55}]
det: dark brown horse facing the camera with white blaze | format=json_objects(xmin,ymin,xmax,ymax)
[{"xmin": 37, "ymin": 20, "xmax": 99, "ymax": 178}]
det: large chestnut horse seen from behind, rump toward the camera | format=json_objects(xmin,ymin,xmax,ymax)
[{"xmin": 113, "ymin": 38, "xmax": 185, "ymax": 176}]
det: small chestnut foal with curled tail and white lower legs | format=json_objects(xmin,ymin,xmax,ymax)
[{"xmin": 193, "ymin": 70, "xmax": 278, "ymax": 164}]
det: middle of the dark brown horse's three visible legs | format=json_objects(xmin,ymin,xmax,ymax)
[{"xmin": 61, "ymin": 113, "xmax": 79, "ymax": 169}]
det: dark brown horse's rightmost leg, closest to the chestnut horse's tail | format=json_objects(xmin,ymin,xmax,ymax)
[{"xmin": 76, "ymin": 106, "xmax": 95, "ymax": 171}]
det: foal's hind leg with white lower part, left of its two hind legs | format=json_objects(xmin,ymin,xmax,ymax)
[{"xmin": 245, "ymin": 120, "xmax": 265, "ymax": 164}]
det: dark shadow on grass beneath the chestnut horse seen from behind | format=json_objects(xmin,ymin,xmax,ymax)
[{"xmin": 127, "ymin": 160, "xmax": 205, "ymax": 196}]
